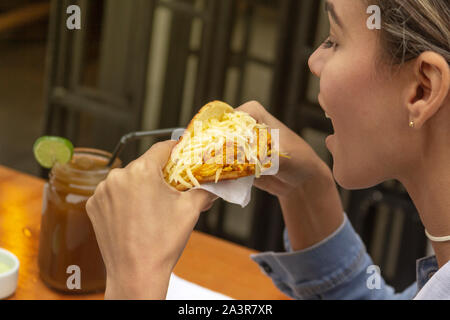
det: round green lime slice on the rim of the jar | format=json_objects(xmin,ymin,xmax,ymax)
[{"xmin": 33, "ymin": 136, "xmax": 73, "ymax": 169}]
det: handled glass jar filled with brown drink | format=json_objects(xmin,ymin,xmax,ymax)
[{"xmin": 39, "ymin": 148, "xmax": 121, "ymax": 293}]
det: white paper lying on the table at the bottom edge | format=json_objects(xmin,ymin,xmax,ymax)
[{"xmin": 166, "ymin": 273, "xmax": 233, "ymax": 300}]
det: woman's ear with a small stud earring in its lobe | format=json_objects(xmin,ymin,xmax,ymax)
[{"xmin": 407, "ymin": 51, "xmax": 450, "ymax": 130}]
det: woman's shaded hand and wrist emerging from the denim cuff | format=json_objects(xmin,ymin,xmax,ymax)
[{"xmin": 238, "ymin": 102, "xmax": 344, "ymax": 251}]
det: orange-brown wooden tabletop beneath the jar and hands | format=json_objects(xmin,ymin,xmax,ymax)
[{"xmin": 0, "ymin": 166, "xmax": 288, "ymax": 300}]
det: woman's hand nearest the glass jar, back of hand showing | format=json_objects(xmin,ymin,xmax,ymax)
[{"xmin": 86, "ymin": 141, "xmax": 217, "ymax": 299}]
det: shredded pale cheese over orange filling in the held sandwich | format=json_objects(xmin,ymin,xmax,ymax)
[{"xmin": 165, "ymin": 111, "xmax": 270, "ymax": 189}]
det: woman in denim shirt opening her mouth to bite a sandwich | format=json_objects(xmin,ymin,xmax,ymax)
[{"xmin": 88, "ymin": 0, "xmax": 450, "ymax": 299}]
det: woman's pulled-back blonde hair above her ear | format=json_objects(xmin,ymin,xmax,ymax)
[{"xmin": 366, "ymin": 0, "xmax": 450, "ymax": 65}]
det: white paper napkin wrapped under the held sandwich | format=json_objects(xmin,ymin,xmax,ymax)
[{"xmin": 172, "ymin": 129, "xmax": 278, "ymax": 208}]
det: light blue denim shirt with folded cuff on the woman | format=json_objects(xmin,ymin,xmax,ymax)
[{"xmin": 251, "ymin": 216, "xmax": 450, "ymax": 300}]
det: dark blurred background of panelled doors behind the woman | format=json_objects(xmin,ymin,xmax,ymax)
[{"xmin": 0, "ymin": 0, "xmax": 430, "ymax": 290}]
